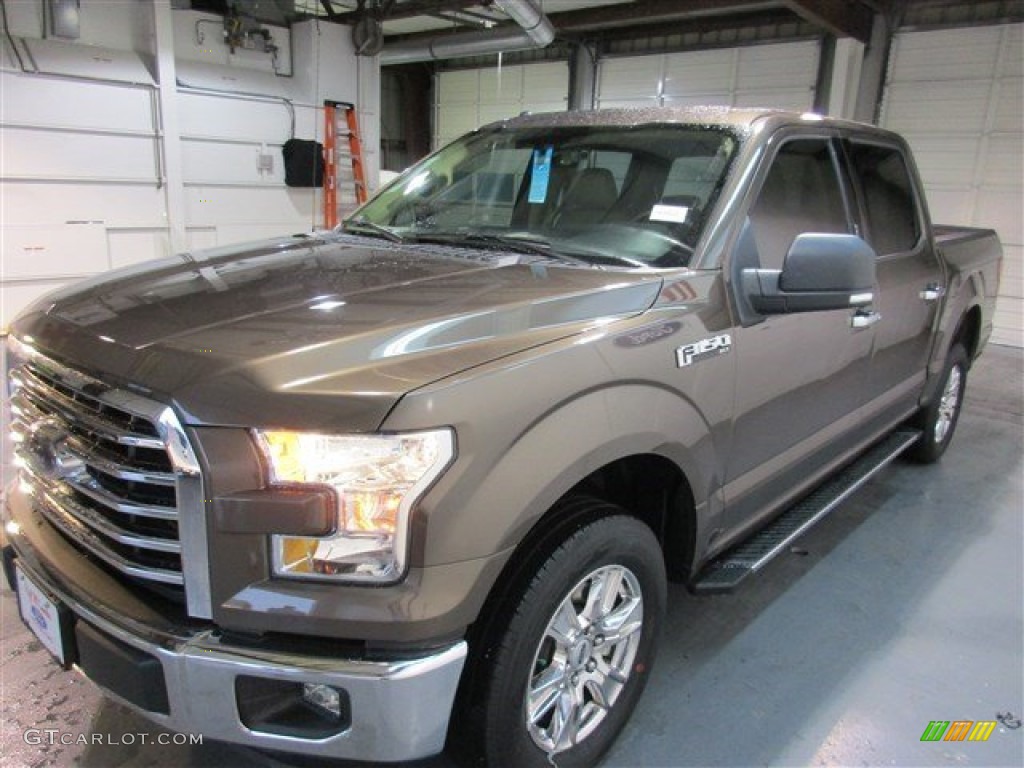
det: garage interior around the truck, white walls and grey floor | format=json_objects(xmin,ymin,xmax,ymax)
[{"xmin": 0, "ymin": 0, "xmax": 1024, "ymax": 766}]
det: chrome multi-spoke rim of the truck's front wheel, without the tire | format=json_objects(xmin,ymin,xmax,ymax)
[{"xmin": 525, "ymin": 565, "xmax": 643, "ymax": 755}]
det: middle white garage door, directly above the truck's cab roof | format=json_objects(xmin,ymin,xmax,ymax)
[{"xmin": 597, "ymin": 41, "xmax": 819, "ymax": 112}]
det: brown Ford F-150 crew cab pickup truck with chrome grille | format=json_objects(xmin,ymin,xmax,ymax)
[{"xmin": 4, "ymin": 109, "xmax": 1000, "ymax": 766}]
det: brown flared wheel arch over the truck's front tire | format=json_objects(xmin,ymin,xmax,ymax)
[{"xmin": 414, "ymin": 382, "xmax": 721, "ymax": 564}]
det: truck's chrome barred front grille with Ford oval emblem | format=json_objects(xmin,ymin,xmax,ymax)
[{"xmin": 9, "ymin": 345, "xmax": 209, "ymax": 615}]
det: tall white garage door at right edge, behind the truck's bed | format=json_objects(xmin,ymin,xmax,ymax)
[{"xmin": 882, "ymin": 25, "xmax": 1024, "ymax": 346}]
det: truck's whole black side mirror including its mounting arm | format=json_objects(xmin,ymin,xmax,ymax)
[{"xmin": 742, "ymin": 232, "xmax": 876, "ymax": 314}]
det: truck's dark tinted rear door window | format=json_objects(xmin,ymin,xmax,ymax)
[{"xmin": 850, "ymin": 142, "xmax": 921, "ymax": 255}]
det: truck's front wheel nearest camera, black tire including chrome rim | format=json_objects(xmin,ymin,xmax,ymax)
[{"xmin": 468, "ymin": 507, "xmax": 667, "ymax": 768}]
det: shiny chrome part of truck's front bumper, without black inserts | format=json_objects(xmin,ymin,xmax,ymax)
[{"xmin": 4, "ymin": 543, "xmax": 466, "ymax": 762}]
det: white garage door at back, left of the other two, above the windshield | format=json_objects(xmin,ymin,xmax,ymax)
[{"xmin": 434, "ymin": 61, "xmax": 569, "ymax": 148}]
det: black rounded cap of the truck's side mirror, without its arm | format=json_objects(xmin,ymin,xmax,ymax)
[{"xmin": 778, "ymin": 232, "xmax": 877, "ymax": 294}]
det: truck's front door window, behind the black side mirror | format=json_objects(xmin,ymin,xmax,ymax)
[{"xmin": 750, "ymin": 138, "xmax": 850, "ymax": 269}]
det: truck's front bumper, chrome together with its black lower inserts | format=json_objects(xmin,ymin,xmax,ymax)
[{"xmin": 4, "ymin": 536, "xmax": 466, "ymax": 762}]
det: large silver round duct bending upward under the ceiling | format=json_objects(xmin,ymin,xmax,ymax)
[{"xmin": 380, "ymin": 0, "xmax": 555, "ymax": 66}]
